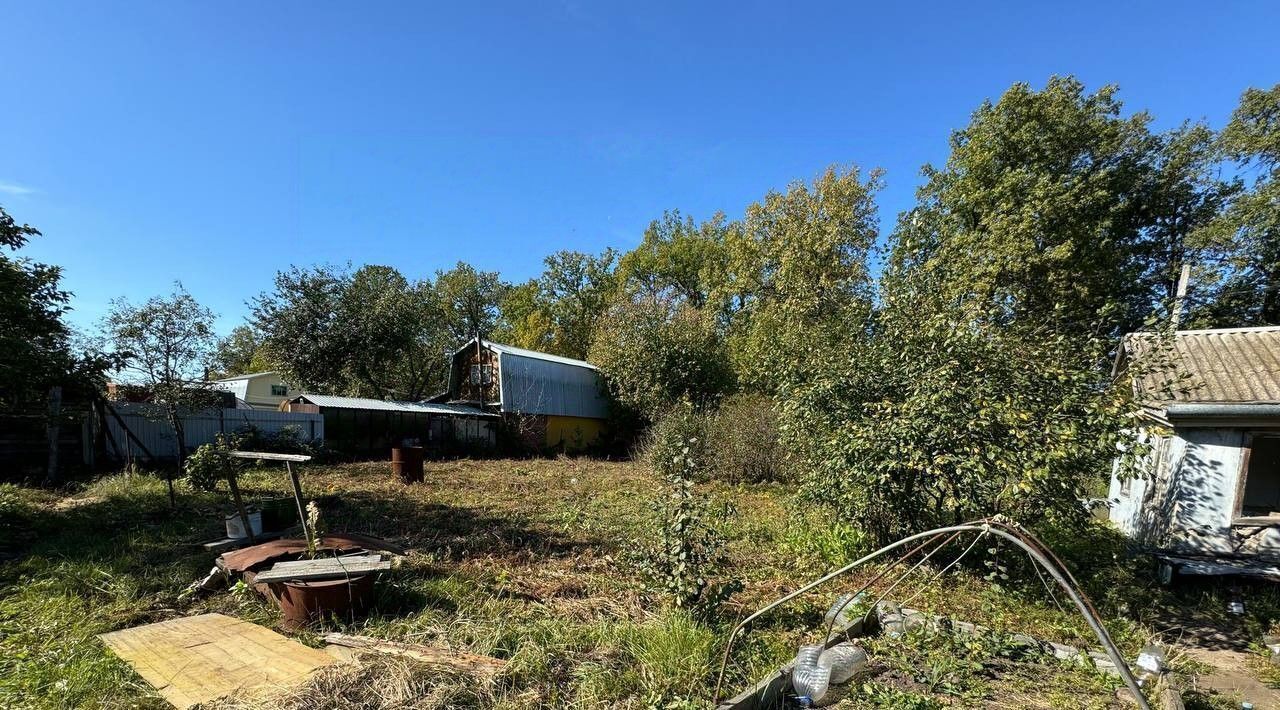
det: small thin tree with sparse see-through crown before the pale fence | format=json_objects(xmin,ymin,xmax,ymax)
[{"xmin": 102, "ymin": 283, "xmax": 216, "ymax": 463}]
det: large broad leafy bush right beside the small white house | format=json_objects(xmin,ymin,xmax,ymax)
[{"xmin": 783, "ymin": 303, "xmax": 1138, "ymax": 542}]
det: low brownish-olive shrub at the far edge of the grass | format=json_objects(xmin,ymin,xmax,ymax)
[{"xmin": 707, "ymin": 394, "xmax": 792, "ymax": 484}]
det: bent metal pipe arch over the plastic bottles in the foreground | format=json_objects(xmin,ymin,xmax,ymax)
[{"xmin": 713, "ymin": 521, "xmax": 1151, "ymax": 710}]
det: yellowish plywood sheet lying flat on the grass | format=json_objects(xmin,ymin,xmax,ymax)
[{"xmin": 99, "ymin": 614, "xmax": 337, "ymax": 707}]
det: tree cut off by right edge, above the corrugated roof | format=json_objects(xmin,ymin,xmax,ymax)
[{"xmin": 1201, "ymin": 84, "xmax": 1280, "ymax": 326}]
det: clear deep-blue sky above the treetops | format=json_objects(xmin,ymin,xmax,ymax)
[{"xmin": 0, "ymin": 0, "xmax": 1280, "ymax": 331}]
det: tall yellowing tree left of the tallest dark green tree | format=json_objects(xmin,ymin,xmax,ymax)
[{"xmin": 716, "ymin": 166, "xmax": 881, "ymax": 393}]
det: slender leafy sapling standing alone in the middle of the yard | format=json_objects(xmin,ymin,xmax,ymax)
[{"xmin": 639, "ymin": 403, "xmax": 741, "ymax": 617}]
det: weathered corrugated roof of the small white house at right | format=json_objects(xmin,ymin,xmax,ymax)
[{"xmin": 1123, "ymin": 326, "xmax": 1280, "ymax": 404}]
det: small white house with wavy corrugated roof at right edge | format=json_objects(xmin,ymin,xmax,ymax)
[{"xmin": 1108, "ymin": 327, "xmax": 1280, "ymax": 577}]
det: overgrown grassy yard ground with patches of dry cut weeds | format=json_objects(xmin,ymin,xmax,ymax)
[{"xmin": 0, "ymin": 458, "xmax": 1280, "ymax": 709}]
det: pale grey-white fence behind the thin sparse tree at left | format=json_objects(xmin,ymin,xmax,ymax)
[{"xmin": 106, "ymin": 402, "xmax": 324, "ymax": 458}]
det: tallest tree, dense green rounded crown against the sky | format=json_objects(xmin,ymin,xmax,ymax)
[{"xmin": 886, "ymin": 77, "xmax": 1158, "ymax": 336}]
